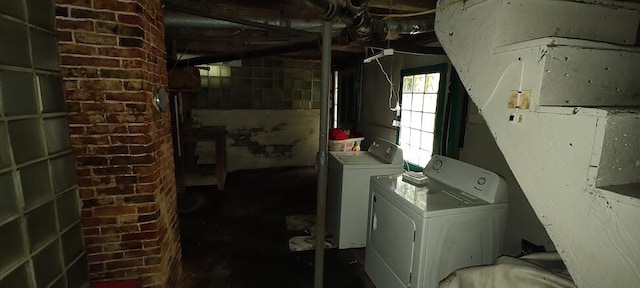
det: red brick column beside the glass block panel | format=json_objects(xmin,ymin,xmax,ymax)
[{"xmin": 56, "ymin": 0, "xmax": 181, "ymax": 287}]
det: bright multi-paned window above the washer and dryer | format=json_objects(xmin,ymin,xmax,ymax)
[{"xmin": 398, "ymin": 69, "xmax": 446, "ymax": 169}]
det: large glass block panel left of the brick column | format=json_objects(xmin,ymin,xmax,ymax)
[{"xmin": 0, "ymin": 0, "xmax": 89, "ymax": 288}]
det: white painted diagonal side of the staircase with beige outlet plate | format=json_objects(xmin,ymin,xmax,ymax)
[{"xmin": 436, "ymin": 0, "xmax": 640, "ymax": 287}]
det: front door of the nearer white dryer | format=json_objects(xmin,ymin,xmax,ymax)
[{"xmin": 367, "ymin": 191, "xmax": 416, "ymax": 288}]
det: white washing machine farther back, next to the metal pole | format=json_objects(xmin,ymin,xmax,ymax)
[{"xmin": 327, "ymin": 139, "xmax": 403, "ymax": 249}]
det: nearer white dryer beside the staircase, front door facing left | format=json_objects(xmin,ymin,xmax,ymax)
[{"xmin": 365, "ymin": 155, "xmax": 507, "ymax": 288}]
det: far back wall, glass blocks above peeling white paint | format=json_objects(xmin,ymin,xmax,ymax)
[{"xmin": 190, "ymin": 58, "xmax": 320, "ymax": 171}]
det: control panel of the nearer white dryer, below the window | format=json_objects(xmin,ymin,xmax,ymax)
[{"xmin": 422, "ymin": 155, "xmax": 507, "ymax": 203}]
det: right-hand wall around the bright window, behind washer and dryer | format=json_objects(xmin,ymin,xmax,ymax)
[{"xmin": 360, "ymin": 54, "xmax": 555, "ymax": 255}]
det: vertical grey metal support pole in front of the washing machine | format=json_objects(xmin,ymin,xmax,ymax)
[{"xmin": 313, "ymin": 21, "xmax": 331, "ymax": 288}]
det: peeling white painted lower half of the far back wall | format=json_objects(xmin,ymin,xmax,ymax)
[{"xmin": 192, "ymin": 109, "xmax": 320, "ymax": 171}]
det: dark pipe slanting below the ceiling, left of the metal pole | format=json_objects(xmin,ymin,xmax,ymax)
[{"xmin": 167, "ymin": 38, "xmax": 318, "ymax": 68}]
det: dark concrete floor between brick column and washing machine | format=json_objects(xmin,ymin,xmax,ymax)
[{"xmin": 178, "ymin": 168, "xmax": 374, "ymax": 288}]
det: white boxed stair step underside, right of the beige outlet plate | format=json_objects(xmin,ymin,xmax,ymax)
[{"xmin": 539, "ymin": 44, "xmax": 640, "ymax": 107}]
